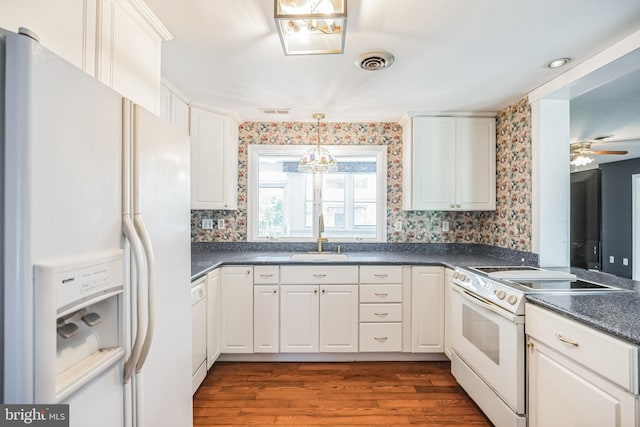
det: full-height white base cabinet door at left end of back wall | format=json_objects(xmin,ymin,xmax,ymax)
[{"xmin": 220, "ymin": 266, "xmax": 253, "ymax": 353}]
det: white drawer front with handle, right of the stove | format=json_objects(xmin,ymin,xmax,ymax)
[{"xmin": 525, "ymin": 304, "xmax": 638, "ymax": 394}]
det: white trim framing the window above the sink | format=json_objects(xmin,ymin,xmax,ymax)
[{"xmin": 247, "ymin": 144, "xmax": 387, "ymax": 243}]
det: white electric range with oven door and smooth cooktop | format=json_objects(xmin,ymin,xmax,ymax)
[{"xmin": 451, "ymin": 266, "xmax": 625, "ymax": 427}]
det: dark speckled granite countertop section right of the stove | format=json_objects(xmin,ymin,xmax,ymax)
[{"xmin": 525, "ymin": 268, "xmax": 640, "ymax": 345}]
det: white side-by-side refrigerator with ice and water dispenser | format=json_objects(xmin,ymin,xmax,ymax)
[{"xmin": 0, "ymin": 30, "xmax": 192, "ymax": 427}]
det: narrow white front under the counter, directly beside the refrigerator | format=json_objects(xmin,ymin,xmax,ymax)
[{"xmin": 191, "ymin": 277, "xmax": 207, "ymax": 393}]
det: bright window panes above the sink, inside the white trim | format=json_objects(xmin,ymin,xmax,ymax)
[{"xmin": 248, "ymin": 145, "xmax": 387, "ymax": 242}]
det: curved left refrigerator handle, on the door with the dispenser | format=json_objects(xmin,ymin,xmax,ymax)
[{"xmin": 122, "ymin": 215, "xmax": 147, "ymax": 384}]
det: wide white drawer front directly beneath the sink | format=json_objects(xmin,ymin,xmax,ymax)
[{"xmin": 280, "ymin": 265, "xmax": 358, "ymax": 285}]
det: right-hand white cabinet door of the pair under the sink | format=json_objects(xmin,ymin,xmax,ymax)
[{"xmin": 320, "ymin": 285, "xmax": 358, "ymax": 352}]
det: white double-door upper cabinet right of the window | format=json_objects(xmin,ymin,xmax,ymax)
[{"xmin": 403, "ymin": 117, "xmax": 496, "ymax": 211}]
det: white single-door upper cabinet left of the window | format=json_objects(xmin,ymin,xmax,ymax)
[{"xmin": 191, "ymin": 106, "xmax": 238, "ymax": 210}]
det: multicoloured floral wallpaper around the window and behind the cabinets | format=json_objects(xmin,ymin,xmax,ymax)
[{"xmin": 191, "ymin": 98, "xmax": 531, "ymax": 251}]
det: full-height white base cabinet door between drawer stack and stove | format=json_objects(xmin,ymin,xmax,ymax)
[{"xmin": 411, "ymin": 267, "xmax": 444, "ymax": 353}]
